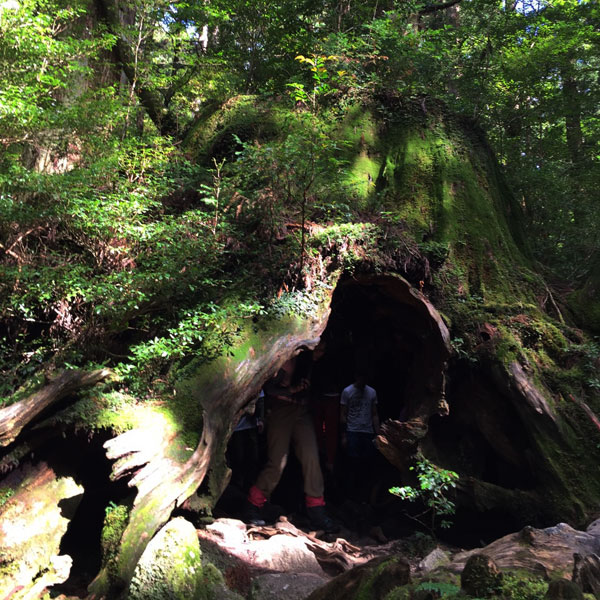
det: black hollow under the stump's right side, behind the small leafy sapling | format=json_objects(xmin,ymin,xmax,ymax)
[{"xmin": 422, "ymin": 361, "xmax": 540, "ymax": 547}]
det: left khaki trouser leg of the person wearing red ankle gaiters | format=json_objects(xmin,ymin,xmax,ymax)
[{"xmin": 255, "ymin": 403, "xmax": 297, "ymax": 498}]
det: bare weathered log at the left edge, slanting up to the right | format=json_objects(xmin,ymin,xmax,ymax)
[{"xmin": 0, "ymin": 369, "xmax": 112, "ymax": 446}]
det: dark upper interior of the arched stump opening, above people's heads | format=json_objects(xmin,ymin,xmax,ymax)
[{"xmin": 322, "ymin": 277, "xmax": 448, "ymax": 421}]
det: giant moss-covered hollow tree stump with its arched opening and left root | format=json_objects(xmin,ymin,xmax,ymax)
[{"xmin": 1, "ymin": 97, "xmax": 600, "ymax": 598}]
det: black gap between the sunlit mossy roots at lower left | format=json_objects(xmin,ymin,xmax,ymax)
[{"xmin": 38, "ymin": 430, "xmax": 133, "ymax": 595}]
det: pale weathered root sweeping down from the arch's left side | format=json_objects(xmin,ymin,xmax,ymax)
[{"xmin": 88, "ymin": 292, "xmax": 338, "ymax": 600}]
